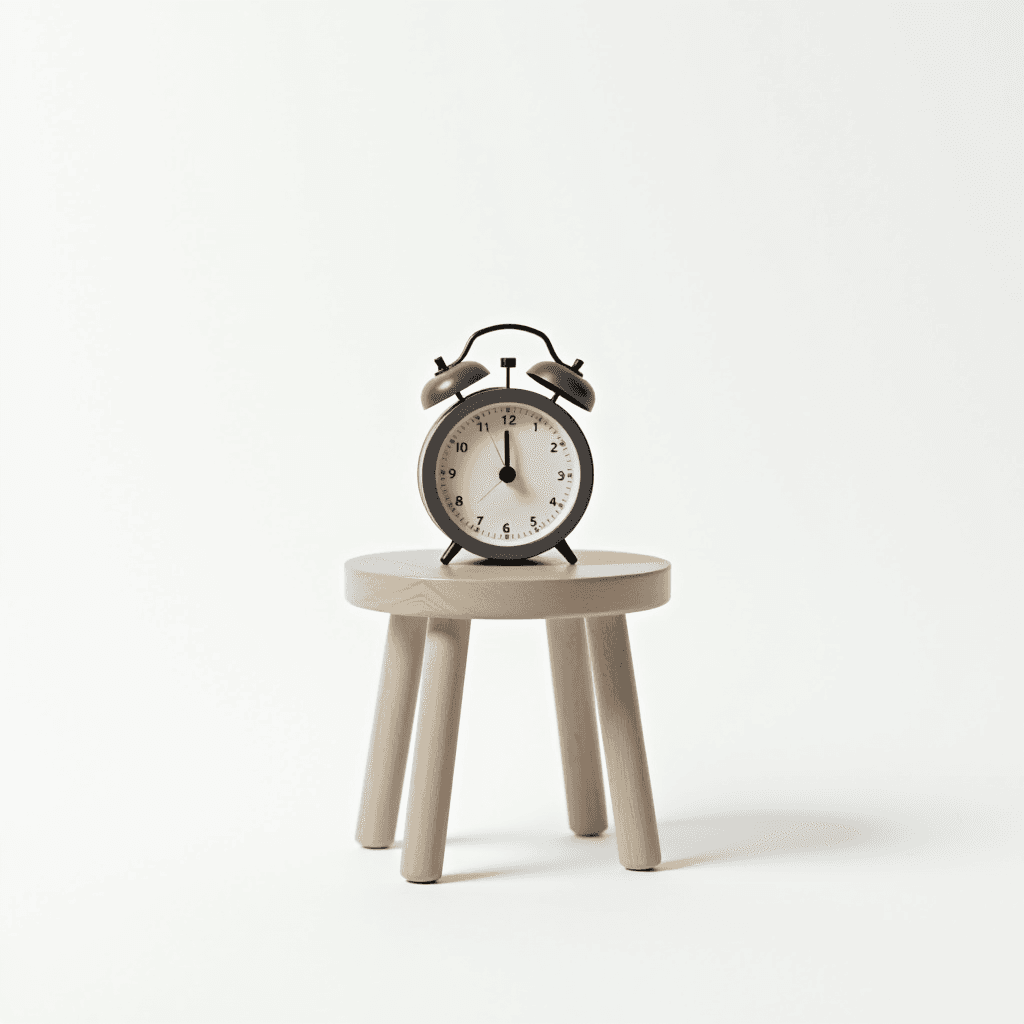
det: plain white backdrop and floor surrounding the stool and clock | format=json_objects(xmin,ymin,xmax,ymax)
[{"xmin": 0, "ymin": 3, "xmax": 1024, "ymax": 1022}]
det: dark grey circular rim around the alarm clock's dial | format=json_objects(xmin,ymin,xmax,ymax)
[{"xmin": 417, "ymin": 387, "xmax": 594, "ymax": 561}]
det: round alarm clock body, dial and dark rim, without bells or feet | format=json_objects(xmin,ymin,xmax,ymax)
[{"xmin": 421, "ymin": 388, "xmax": 593, "ymax": 558}]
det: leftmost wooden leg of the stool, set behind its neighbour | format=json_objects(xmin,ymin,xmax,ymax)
[{"xmin": 355, "ymin": 615, "xmax": 427, "ymax": 849}]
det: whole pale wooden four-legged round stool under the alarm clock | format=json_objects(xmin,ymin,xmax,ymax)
[{"xmin": 345, "ymin": 551, "xmax": 670, "ymax": 882}]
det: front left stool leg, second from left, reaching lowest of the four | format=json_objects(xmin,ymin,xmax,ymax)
[{"xmin": 401, "ymin": 618, "xmax": 469, "ymax": 882}]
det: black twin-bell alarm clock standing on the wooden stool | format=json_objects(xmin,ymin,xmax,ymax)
[{"xmin": 417, "ymin": 324, "xmax": 595, "ymax": 565}]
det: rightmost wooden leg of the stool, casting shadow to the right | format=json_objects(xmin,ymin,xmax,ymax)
[{"xmin": 587, "ymin": 615, "xmax": 662, "ymax": 871}]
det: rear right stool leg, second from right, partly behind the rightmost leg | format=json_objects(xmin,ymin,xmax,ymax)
[{"xmin": 547, "ymin": 618, "xmax": 608, "ymax": 836}]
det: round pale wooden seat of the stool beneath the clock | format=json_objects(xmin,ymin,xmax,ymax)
[{"xmin": 345, "ymin": 550, "xmax": 671, "ymax": 618}]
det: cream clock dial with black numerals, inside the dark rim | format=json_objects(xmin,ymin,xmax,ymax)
[{"xmin": 435, "ymin": 401, "xmax": 580, "ymax": 547}]
